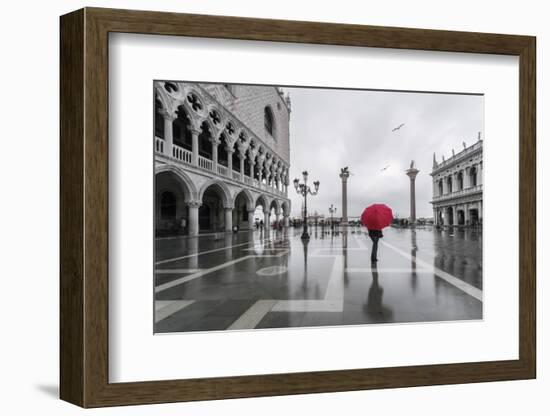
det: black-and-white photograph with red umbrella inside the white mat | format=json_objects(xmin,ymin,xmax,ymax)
[{"xmin": 153, "ymin": 80, "xmax": 484, "ymax": 334}]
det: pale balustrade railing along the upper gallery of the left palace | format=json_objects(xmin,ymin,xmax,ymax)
[{"xmin": 155, "ymin": 137, "xmax": 287, "ymax": 197}]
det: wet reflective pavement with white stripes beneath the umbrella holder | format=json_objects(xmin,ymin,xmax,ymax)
[{"xmin": 154, "ymin": 227, "xmax": 483, "ymax": 333}]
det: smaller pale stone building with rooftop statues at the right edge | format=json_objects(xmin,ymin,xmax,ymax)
[{"xmin": 430, "ymin": 136, "xmax": 483, "ymax": 227}]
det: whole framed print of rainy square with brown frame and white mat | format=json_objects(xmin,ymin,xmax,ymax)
[{"xmin": 60, "ymin": 8, "xmax": 536, "ymax": 407}]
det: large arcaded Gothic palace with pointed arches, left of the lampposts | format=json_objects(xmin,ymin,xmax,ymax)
[{"xmin": 154, "ymin": 81, "xmax": 290, "ymax": 236}]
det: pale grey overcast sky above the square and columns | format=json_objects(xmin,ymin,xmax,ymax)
[{"xmin": 285, "ymin": 88, "xmax": 483, "ymax": 217}]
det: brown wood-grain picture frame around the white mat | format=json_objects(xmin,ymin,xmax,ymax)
[{"xmin": 60, "ymin": 8, "xmax": 536, "ymax": 407}]
